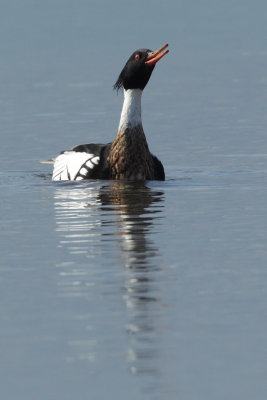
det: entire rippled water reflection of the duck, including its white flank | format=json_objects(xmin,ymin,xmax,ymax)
[{"xmin": 55, "ymin": 182, "xmax": 163, "ymax": 392}]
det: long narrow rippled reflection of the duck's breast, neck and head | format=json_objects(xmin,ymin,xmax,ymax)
[{"xmin": 100, "ymin": 182, "xmax": 163, "ymax": 377}]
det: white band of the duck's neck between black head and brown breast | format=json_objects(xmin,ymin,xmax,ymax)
[{"xmin": 118, "ymin": 89, "xmax": 142, "ymax": 131}]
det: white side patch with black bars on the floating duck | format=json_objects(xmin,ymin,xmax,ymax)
[{"xmin": 52, "ymin": 151, "xmax": 99, "ymax": 181}]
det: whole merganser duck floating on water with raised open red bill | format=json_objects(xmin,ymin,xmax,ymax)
[{"xmin": 52, "ymin": 44, "xmax": 169, "ymax": 181}]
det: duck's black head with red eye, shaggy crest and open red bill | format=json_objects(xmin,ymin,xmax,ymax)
[{"xmin": 114, "ymin": 44, "xmax": 169, "ymax": 90}]
